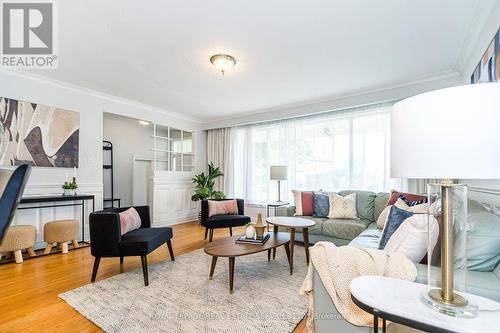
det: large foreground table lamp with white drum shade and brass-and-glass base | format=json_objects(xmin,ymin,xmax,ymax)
[{"xmin": 391, "ymin": 83, "xmax": 500, "ymax": 317}]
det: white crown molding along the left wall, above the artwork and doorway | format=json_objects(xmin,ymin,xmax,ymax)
[{"xmin": 0, "ymin": 69, "xmax": 202, "ymax": 124}]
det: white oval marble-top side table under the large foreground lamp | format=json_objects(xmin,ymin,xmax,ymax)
[{"xmin": 351, "ymin": 275, "xmax": 500, "ymax": 333}]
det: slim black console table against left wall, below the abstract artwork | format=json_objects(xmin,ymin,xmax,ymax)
[{"xmin": 17, "ymin": 194, "xmax": 95, "ymax": 242}]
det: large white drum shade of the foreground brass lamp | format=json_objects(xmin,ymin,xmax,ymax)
[{"xmin": 391, "ymin": 83, "xmax": 500, "ymax": 179}]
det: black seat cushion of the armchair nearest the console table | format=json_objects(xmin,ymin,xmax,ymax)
[{"xmin": 120, "ymin": 227, "xmax": 173, "ymax": 256}]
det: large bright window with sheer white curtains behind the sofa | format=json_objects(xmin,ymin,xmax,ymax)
[{"xmin": 233, "ymin": 104, "xmax": 390, "ymax": 203}]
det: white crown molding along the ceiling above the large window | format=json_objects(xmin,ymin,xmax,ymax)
[{"xmin": 202, "ymin": 70, "xmax": 462, "ymax": 129}]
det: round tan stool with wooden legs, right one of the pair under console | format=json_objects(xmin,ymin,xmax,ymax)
[{"xmin": 43, "ymin": 220, "xmax": 80, "ymax": 254}]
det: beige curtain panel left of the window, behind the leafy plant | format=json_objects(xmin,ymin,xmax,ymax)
[{"xmin": 207, "ymin": 127, "xmax": 236, "ymax": 197}]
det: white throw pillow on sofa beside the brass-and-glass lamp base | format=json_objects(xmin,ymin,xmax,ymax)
[{"xmin": 384, "ymin": 214, "xmax": 439, "ymax": 263}]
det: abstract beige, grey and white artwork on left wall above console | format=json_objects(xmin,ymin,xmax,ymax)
[{"xmin": 0, "ymin": 97, "xmax": 79, "ymax": 168}]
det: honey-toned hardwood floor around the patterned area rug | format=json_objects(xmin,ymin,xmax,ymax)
[{"xmin": 0, "ymin": 222, "xmax": 307, "ymax": 333}]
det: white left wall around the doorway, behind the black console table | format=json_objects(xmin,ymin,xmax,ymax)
[{"xmin": 0, "ymin": 71, "xmax": 206, "ymax": 246}]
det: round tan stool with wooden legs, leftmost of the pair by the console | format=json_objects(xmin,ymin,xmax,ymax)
[{"xmin": 0, "ymin": 225, "xmax": 36, "ymax": 264}]
